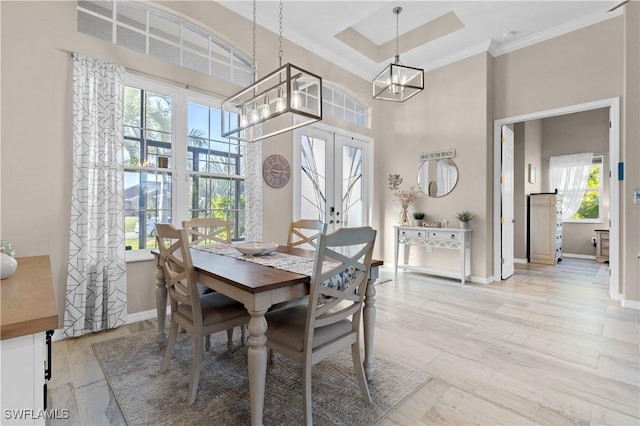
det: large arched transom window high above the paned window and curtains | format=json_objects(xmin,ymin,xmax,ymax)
[{"xmin": 77, "ymin": 0, "xmax": 253, "ymax": 87}]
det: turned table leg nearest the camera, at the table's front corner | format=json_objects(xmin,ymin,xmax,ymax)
[{"xmin": 247, "ymin": 310, "xmax": 267, "ymax": 426}]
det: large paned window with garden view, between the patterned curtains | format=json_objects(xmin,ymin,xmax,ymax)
[{"xmin": 124, "ymin": 86, "xmax": 245, "ymax": 250}]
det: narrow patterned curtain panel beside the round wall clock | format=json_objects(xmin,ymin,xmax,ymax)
[{"xmin": 244, "ymin": 141, "xmax": 262, "ymax": 241}]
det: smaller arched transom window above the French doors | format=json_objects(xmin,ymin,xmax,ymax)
[{"xmin": 322, "ymin": 80, "xmax": 370, "ymax": 128}]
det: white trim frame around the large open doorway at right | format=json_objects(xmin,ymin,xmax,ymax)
[{"xmin": 493, "ymin": 97, "xmax": 620, "ymax": 300}]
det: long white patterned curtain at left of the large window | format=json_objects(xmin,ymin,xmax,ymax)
[{"xmin": 64, "ymin": 55, "xmax": 127, "ymax": 336}]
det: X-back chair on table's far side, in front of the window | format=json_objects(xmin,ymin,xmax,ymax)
[{"xmin": 182, "ymin": 217, "xmax": 247, "ymax": 351}]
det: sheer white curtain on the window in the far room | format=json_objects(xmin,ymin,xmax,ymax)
[{"xmin": 549, "ymin": 152, "xmax": 593, "ymax": 220}]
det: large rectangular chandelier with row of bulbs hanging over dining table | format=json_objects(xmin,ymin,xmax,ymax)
[{"xmin": 222, "ymin": 0, "xmax": 322, "ymax": 142}]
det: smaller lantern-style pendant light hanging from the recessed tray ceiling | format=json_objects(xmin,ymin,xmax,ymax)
[{"xmin": 373, "ymin": 7, "xmax": 424, "ymax": 102}]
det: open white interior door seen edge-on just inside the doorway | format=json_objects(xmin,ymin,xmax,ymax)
[{"xmin": 500, "ymin": 126, "xmax": 515, "ymax": 280}]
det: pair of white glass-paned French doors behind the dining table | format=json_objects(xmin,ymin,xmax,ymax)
[{"xmin": 293, "ymin": 126, "xmax": 371, "ymax": 232}]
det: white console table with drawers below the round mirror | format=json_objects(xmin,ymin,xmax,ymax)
[{"xmin": 394, "ymin": 225, "xmax": 471, "ymax": 284}]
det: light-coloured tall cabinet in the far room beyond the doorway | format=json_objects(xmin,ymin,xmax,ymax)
[{"xmin": 528, "ymin": 193, "xmax": 562, "ymax": 265}]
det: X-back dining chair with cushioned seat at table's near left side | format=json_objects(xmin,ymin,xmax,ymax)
[{"xmin": 156, "ymin": 223, "xmax": 249, "ymax": 405}]
